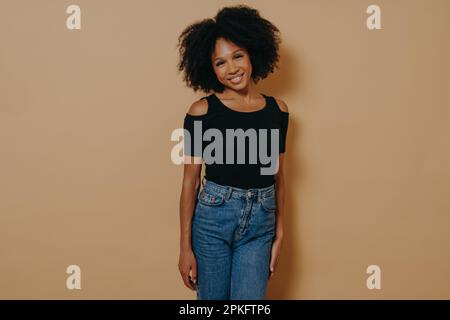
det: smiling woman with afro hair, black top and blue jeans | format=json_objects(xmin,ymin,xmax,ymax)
[{"xmin": 178, "ymin": 5, "xmax": 289, "ymax": 300}]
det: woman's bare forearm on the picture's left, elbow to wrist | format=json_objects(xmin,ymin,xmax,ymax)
[{"xmin": 180, "ymin": 178, "xmax": 200, "ymax": 250}]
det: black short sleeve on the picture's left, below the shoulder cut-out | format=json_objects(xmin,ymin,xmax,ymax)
[{"xmin": 183, "ymin": 113, "xmax": 206, "ymax": 157}]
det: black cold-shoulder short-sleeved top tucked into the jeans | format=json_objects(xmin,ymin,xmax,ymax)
[{"xmin": 184, "ymin": 94, "xmax": 289, "ymax": 189}]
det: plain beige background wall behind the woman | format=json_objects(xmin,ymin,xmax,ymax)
[{"xmin": 0, "ymin": 0, "xmax": 450, "ymax": 299}]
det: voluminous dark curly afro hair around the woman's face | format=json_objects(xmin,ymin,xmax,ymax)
[{"xmin": 177, "ymin": 5, "xmax": 281, "ymax": 92}]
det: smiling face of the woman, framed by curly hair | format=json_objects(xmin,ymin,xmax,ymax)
[{"xmin": 211, "ymin": 38, "xmax": 252, "ymax": 90}]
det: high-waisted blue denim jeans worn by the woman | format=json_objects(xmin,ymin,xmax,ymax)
[{"xmin": 192, "ymin": 179, "xmax": 276, "ymax": 300}]
